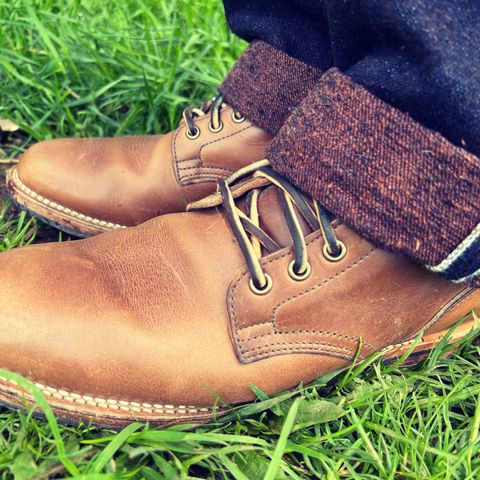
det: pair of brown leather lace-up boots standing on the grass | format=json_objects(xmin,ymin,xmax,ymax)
[{"xmin": 0, "ymin": 97, "xmax": 480, "ymax": 427}]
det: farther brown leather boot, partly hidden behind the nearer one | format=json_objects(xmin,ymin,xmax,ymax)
[{"xmin": 7, "ymin": 96, "xmax": 270, "ymax": 236}]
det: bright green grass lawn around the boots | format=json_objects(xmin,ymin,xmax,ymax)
[{"xmin": 0, "ymin": 0, "xmax": 480, "ymax": 480}]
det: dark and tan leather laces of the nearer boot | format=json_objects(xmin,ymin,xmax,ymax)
[{"xmin": 189, "ymin": 160, "xmax": 346, "ymax": 294}]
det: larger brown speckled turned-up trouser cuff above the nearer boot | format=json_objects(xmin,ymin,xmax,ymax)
[{"xmin": 267, "ymin": 69, "xmax": 480, "ymax": 280}]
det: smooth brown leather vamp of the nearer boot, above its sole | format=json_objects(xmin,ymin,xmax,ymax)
[{"xmin": 0, "ymin": 211, "xmax": 338, "ymax": 406}]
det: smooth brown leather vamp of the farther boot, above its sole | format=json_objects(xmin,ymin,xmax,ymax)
[{"xmin": 18, "ymin": 134, "xmax": 186, "ymax": 226}]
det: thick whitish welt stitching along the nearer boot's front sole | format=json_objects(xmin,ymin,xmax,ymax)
[{"xmin": 1, "ymin": 377, "xmax": 218, "ymax": 414}]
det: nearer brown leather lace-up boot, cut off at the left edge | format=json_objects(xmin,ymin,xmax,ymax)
[{"xmin": 0, "ymin": 163, "xmax": 480, "ymax": 427}]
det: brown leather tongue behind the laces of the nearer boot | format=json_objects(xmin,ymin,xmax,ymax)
[{"xmin": 258, "ymin": 185, "xmax": 313, "ymax": 248}]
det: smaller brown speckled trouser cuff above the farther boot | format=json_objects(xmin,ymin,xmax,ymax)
[{"xmin": 219, "ymin": 41, "xmax": 322, "ymax": 135}]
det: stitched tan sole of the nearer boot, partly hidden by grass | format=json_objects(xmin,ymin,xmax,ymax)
[{"xmin": 0, "ymin": 316, "xmax": 477, "ymax": 429}]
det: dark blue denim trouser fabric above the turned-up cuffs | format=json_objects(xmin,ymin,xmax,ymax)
[{"xmin": 224, "ymin": 0, "xmax": 480, "ymax": 155}]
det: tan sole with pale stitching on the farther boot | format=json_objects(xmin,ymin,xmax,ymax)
[{"xmin": 6, "ymin": 167, "xmax": 126, "ymax": 238}]
